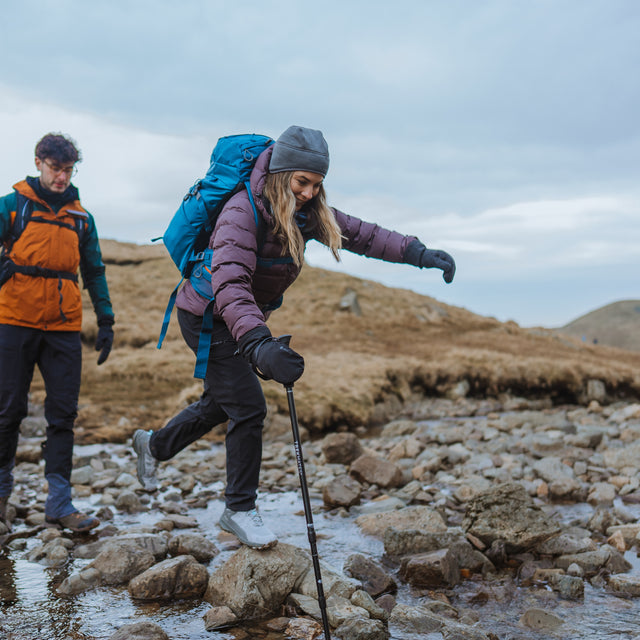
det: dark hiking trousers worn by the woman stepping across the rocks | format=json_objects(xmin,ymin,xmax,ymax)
[{"xmin": 149, "ymin": 309, "xmax": 267, "ymax": 511}]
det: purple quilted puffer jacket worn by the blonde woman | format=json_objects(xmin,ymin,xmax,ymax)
[{"xmin": 176, "ymin": 147, "xmax": 416, "ymax": 340}]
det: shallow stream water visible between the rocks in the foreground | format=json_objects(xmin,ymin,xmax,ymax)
[{"xmin": 0, "ymin": 445, "xmax": 640, "ymax": 640}]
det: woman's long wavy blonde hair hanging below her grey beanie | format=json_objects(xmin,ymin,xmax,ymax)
[{"xmin": 264, "ymin": 171, "xmax": 342, "ymax": 267}]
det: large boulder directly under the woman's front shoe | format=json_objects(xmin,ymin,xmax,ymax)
[{"xmin": 204, "ymin": 543, "xmax": 312, "ymax": 620}]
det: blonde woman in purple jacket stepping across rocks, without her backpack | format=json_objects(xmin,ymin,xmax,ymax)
[{"xmin": 133, "ymin": 126, "xmax": 455, "ymax": 549}]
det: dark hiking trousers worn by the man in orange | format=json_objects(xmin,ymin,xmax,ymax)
[{"xmin": 0, "ymin": 324, "xmax": 82, "ymax": 495}]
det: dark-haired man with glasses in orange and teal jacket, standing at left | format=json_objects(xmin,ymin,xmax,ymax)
[{"xmin": 0, "ymin": 133, "xmax": 114, "ymax": 532}]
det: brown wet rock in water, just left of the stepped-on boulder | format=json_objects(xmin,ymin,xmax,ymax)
[{"xmin": 129, "ymin": 556, "xmax": 209, "ymax": 600}]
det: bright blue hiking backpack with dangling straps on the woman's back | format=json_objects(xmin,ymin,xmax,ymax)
[{"xmin": 158, "ymin": 133, "xmax": 273, "ymax": 378}]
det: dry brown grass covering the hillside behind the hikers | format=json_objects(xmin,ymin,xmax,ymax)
[{"xmin": 28, "ymin": 240, "xmax": 640, "ymax": 442}]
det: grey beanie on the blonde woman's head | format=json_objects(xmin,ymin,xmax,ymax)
[{"xmin": 269, "ymin": 126, "xmax": 329, "ymax": 176}]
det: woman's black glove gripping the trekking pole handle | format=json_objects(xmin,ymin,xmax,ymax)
[{"xmin": 238, "ymin": 325, "xmax": 304, "ymax": 387}]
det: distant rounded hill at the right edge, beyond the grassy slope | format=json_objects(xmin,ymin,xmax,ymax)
[{"xmin": 558, "ymin": 300, "xmax": 640, "ymax": 351}]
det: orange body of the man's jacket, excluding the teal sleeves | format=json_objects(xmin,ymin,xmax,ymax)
[{"xmin": 0, "ymin": 180, "xmax": 89, "ymax": 331}]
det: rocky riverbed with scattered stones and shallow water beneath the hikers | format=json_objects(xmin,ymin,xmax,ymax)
[{"xmin": 0, "ymin": 395, "xmax": 640, "ymax": 640}]
